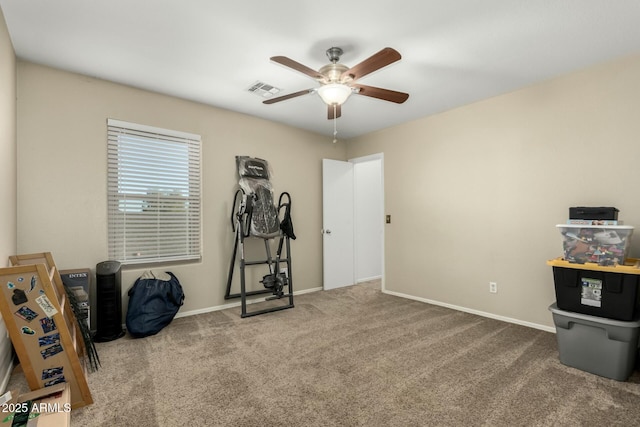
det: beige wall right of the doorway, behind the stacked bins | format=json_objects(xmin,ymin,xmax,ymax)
[{"xmin": 348, "ymin": 56, "xmax": 640, "ymax": 326}]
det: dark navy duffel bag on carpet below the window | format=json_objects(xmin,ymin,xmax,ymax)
[{"xmin": 127, "ymin": 271, "xmax": 184, "ymax": 338}]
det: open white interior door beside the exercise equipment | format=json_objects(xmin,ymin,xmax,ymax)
[{"xmin": 322, "ymin": 159, "xmax": 355, "ymax": 290}]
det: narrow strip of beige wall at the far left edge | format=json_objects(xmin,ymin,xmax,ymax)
[{"xmin": 0, "ymin": 5, "xmax": 16, "ymax": 390}]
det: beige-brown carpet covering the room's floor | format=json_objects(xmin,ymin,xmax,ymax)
[{"xmin": 10, "ymin": 282, "xmax": 640, "ymax": 427}]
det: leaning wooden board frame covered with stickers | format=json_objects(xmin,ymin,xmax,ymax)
[{"xmin": 0, "ymin": 252, "xmax": 93, "ymax": 409}]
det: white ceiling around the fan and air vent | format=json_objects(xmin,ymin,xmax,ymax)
[{"xmin": 0, "ymin": 0, "xmax": 640, "ymax": 138}]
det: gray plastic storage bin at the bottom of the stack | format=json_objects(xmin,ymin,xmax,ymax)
[{"xmin": 549, "ymin": 303, "xmax": 640, "ymax": 381}]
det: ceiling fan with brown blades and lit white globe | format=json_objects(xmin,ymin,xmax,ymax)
[{"xmin": 263, "ymin": 47, "xmax": 409, "ymax": 120}]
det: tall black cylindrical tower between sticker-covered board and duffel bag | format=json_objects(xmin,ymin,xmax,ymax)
[{"xmin": 93, "ymin": 261, "xmax": 124, "ymax": 342}]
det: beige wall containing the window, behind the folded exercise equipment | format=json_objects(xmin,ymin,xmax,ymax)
[{"xmin": 18, "ymin": 62, "xmax": 346, "ymax": 312}]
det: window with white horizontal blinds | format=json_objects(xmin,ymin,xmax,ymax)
[{"xmin": 107, "ymin": 119, "xmax": 201, "ymax": 264}]
